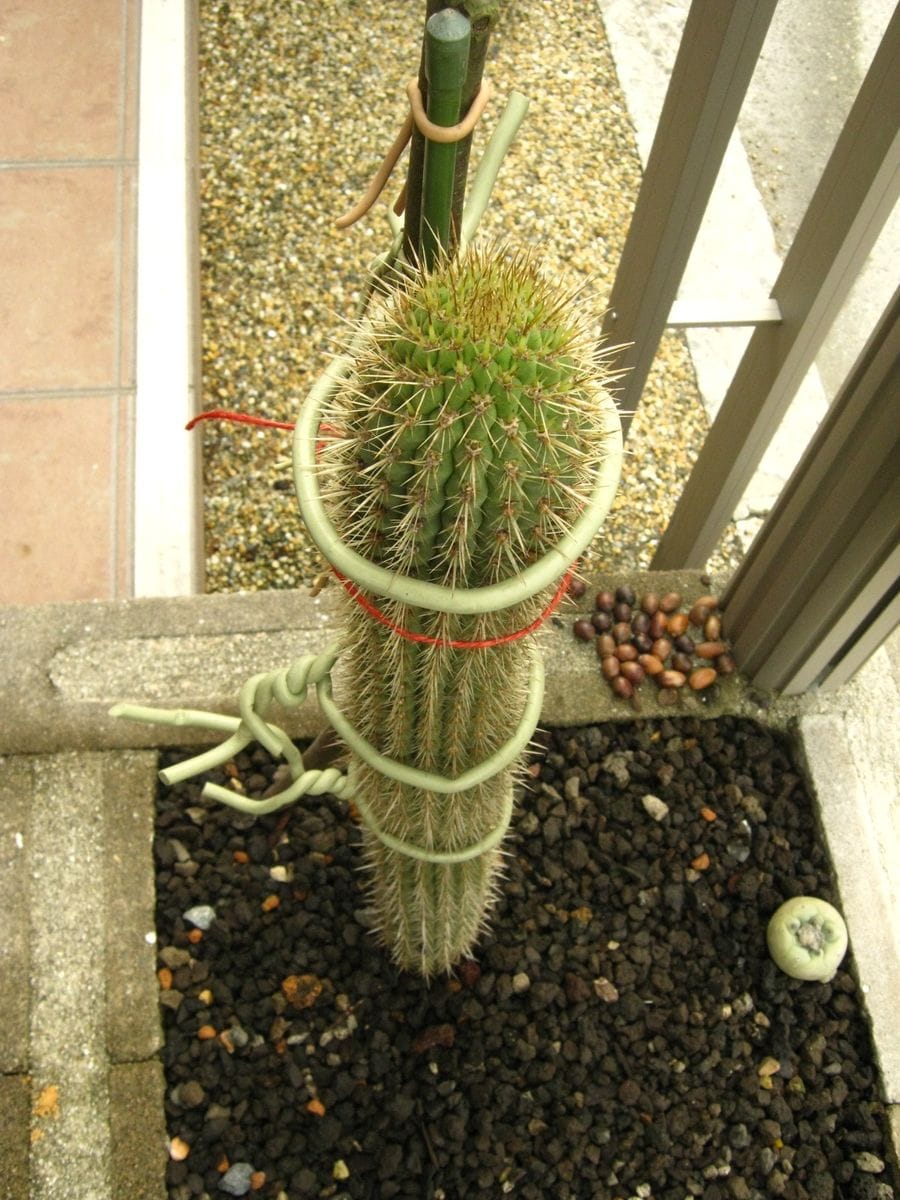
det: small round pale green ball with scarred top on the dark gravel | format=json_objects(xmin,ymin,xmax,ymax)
[{"xmin": 766, "ymin": 896, "xmax": 847, "ymax": 983}]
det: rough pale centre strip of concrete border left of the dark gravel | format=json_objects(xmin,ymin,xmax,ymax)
[{"xmin": 28, "ymin": 752, "xmax": 109, "ymax": 1200}]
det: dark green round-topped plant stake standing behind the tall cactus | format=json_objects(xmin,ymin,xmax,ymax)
[{"xmin": 419, "ymin": 8, "xmax": 472, "ymax": 270}]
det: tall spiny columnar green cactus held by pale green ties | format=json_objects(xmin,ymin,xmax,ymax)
[{"xmin": 319, "ymin": 248, "xmax": 618, "ymax": 976}]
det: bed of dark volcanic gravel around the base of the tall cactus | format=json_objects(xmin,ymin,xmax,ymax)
[{"xmin": 156, "ymin": 719, "xmax": 895, "ymax": 1200}]
